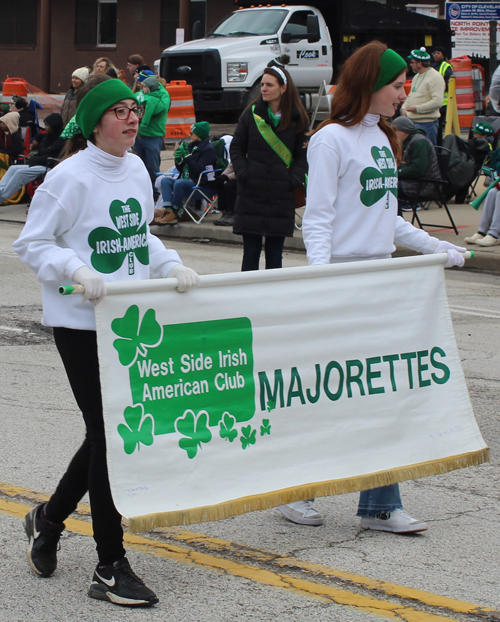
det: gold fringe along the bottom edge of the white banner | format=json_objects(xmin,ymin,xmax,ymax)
[{"xmin": 129, "ymin": 447, "xmax": 490, "ymax": 533}]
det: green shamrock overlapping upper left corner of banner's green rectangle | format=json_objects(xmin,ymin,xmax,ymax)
[{"xmin": 111, "ymin": 305, "xmax": 162, "ymax": 367}]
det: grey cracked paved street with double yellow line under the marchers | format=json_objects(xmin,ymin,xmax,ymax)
[{"xmin": 0, "ymin": 222, "xmax": 500, "ymax": 622}]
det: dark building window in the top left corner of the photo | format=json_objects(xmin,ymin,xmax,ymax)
[{"xmin": 0, "ymin": 0, "xmax": 37, "ymax": 45}]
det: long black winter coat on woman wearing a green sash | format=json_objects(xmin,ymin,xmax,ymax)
[{"xmin": 230, "ymin": 99, "xmax": 307, "ymax": 237}]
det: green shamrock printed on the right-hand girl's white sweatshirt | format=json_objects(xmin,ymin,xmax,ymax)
[{"xmin": 359, "ymin": 147, "xmax": 398, "ymax": 209}]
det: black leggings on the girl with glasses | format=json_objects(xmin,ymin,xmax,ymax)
[{"xmin": 45, "ymin": 328, "xmax": 125, "ymax": 565}]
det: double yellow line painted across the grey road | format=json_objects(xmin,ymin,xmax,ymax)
[{"xmin": 0, "ymin": 483, "xmax": 495, "ymax": 622}]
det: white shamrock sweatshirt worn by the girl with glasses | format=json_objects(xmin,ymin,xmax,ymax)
[{"xmin": 13, "ymin": 142, "xmax": 182, "ymax": 330}]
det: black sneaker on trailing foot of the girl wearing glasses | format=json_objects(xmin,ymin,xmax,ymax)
[{"xmin": 24, "ymin": 503, "xmax": 64, "ymax": 577}]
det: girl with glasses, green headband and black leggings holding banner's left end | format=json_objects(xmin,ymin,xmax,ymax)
[{"xmin": 14, "ymin": 76, "xmax": 198, "ymax": 607}]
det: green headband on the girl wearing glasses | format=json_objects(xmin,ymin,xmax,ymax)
[{"xmin": 75, "ymin": 79, "xmax": 138, "ymax": 138}]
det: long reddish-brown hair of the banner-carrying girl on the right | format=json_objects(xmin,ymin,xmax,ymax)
[{"xmin": 312, "ymin": 41, "xmax": 401, "ymax": 162}]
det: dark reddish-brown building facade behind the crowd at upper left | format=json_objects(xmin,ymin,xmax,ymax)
[{"xmin": 0, "ymin": 0, "xmax": 235, "ymax": 93}]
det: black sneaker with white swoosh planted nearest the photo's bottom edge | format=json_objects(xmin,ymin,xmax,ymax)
[{"xmin": 88, "ymin": 557, "xmax": 158, "ymax": 607}]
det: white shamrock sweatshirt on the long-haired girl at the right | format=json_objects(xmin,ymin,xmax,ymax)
[{"xmin": 302, "ymin": 114, "xmax": 439, "ymax": 265}]
